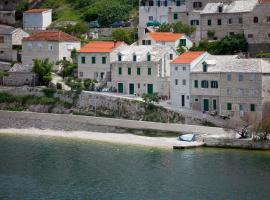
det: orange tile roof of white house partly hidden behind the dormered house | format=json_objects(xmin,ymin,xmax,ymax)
[{"xmin": 148, "ymin": 32, "xmax": 184, "ymax": 42}]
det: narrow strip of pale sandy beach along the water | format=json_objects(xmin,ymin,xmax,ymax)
[{"xmin": 0, "ymin": 128, "xmax": 203, "ymax": 149}]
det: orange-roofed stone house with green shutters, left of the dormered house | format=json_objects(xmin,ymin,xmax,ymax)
[{"xmin": 78, "ymin": 41, "xmax": 126, "ymax": 82}]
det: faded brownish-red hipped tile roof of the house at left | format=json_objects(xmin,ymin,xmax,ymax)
[{"xmin": 23, "ymin": 31, "xmax": 80, "ymax": 42}]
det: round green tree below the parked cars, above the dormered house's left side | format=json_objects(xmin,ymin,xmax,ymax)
[{"xmin": 112, "ymin": 28, "xmax": 138, "ymax": 44}]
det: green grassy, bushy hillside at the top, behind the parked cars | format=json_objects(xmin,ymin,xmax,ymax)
[{"xmin": 30, "ymin": 0, "xmax": 138, "ymax": 26}]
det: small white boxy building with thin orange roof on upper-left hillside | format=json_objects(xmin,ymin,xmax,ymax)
[{"xmin": 23, "ymin": 8, "xmax": 52, "ymax": 30}]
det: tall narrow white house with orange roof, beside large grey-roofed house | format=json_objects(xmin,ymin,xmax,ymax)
[{"xmin": 170, "ymin": 52, "xmax": 207, "ymax": 108}]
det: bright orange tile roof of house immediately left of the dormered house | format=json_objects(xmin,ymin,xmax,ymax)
[{"xmin": 79, "ymin": 41, "xmax": 124, "ymax": 53}]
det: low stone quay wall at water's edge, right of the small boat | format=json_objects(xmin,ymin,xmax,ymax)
[{"xmin": 204, "ymin": 137, "xmax": 270, "ymax": 150}]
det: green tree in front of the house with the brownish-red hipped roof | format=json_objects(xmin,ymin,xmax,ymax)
[{"xmin": 33, "ymin": 58, "xmax": 53, "ymax": 86}]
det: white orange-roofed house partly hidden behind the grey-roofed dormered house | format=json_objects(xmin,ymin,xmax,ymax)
[{"xmin": 139, "ymin": 32, "xmax": 193, "ymax": 50}]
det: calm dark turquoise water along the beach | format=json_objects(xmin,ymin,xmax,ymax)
[{"xmin": 0, "ymin": 134, "xmax": 270, "ymax": 200}]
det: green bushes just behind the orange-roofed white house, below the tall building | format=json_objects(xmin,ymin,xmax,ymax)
[{"xmin": 158, "ymin": 22, "xmax": 196, "ymax": 36}]
